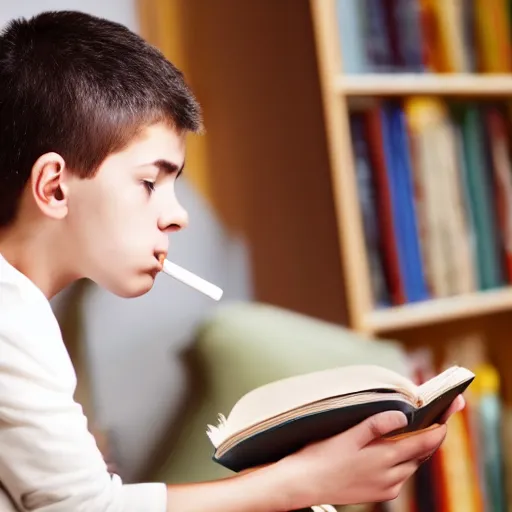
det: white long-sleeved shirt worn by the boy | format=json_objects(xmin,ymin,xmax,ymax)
[{"xmin": 0, "ymin": 255, "xmax": 167, "ymax": 512}]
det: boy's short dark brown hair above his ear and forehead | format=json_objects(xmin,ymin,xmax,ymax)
[{"xmin": 0, "ymin": 11, "xmax": 202, "ymax": 227}]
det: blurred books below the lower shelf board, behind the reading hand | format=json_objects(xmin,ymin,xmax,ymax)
[{"xmin": 405, "ymin": 336, "xmax": 512, "ymax": 512}]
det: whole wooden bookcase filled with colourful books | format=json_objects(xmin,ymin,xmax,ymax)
[{"xmin": 310, "ymin": 5, "xmax": 512, "ymax": 511}]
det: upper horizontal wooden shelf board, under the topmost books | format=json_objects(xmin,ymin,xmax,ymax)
[{"xmin": 334, "ymin": 73, "xmax": 512, "ymax": 97}]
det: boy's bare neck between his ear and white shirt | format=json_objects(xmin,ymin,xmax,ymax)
[{"xmin": 0, "ymin": 218, "xmax": 78, "ymax": 299}]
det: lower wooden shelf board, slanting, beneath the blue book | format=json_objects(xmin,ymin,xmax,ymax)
[{"xmin": 367, "ymin": 287, "xmax": 512, "ymax": 333}]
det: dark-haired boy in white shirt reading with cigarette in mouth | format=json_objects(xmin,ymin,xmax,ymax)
[{"xmin": 0, "ymin": 12, "xmax": 463, "ymax": 512}]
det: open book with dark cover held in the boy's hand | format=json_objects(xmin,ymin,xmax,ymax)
[{"xmin": 207, "ymin": 365, "xmax": 474, "ymax": 472}]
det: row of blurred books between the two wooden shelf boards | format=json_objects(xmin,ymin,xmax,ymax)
[{"xmin": 350, "ymin": 96, "xmax": 512, "ymax": 308}]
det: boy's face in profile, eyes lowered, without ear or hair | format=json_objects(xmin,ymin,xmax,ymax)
[{"xmin": 65, "ymin": 124, "xmax": 188, "ymax": 297}]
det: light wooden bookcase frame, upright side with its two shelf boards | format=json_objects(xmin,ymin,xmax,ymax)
[{"xmin": 310, "ymin": 0, "xmax": 512, "ymax": 335}]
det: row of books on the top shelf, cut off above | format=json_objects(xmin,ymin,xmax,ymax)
[{"xmin": 336, "ymin": 0, "xmax": 512, "ymax": 74}]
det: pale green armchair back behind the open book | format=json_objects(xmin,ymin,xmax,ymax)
[{"xmin": 151, "ymin": 303, "xmax": 407, "ymax": 492}]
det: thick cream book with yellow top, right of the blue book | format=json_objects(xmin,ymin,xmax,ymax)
[{"xmin": 405, "ymin": 97, "xmax": 476, "ymax": 297}]
